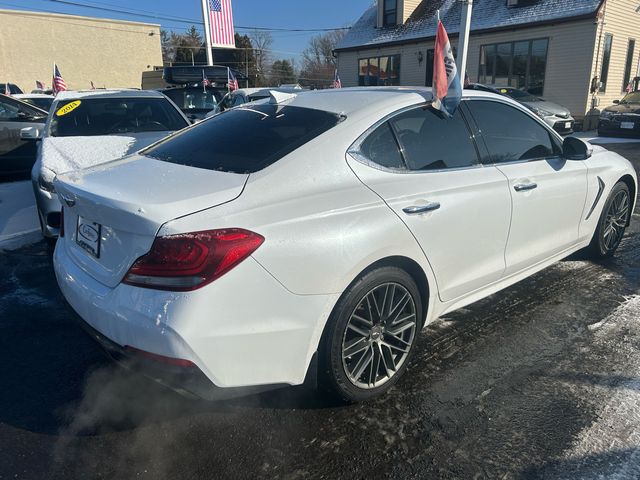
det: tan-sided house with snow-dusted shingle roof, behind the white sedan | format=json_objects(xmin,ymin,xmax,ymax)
[{"xmin": 336, "ymin": 0, "xmax": 640, "ymax": 128}]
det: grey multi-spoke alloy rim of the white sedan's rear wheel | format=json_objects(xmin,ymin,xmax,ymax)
[{"xmin": 342, "ymin": 283, "xmax": 418, "ymax": 389}]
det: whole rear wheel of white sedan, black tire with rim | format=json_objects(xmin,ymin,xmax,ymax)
[{"xmin": 319, "ymin": 267, "xmax": 424, "ymax": 403}]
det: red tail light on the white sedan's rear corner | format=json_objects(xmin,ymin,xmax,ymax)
[{"xmin": 122, "ymin": 228, "xmax": 264, "ymax": 291}]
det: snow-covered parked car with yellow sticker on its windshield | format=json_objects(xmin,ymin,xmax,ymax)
[{"xmin": 29, "ymin": 90, "xmax": 189, "ymax": 238}]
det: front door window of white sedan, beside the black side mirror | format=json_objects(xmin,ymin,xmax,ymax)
[{"xmin": 467, "ymin": 100, "xmax": 561, "ymax": 163}]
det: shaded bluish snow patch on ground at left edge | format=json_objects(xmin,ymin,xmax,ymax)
[{"xmin": 0, "ymin": 181, "xmax": 40, "ymax": 251}]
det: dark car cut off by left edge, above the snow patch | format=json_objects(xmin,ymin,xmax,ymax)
[{"xmin": 0, "ymin": 94, "xmax": 47, "ymax": 181}]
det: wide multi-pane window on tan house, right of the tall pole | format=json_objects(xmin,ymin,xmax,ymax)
[{"xmin": 478, "ymin": 38, "xmax": 549, "ymax": 95}]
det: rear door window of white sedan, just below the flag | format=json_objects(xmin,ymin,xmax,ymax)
[{"xmin": 390, "ymin": 107, "xmax": 478, "ymax": 171}]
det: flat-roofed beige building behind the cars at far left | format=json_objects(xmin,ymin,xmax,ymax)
[{"xmin": 0, "ymin": 10, "xmax": 162, "ymax": 92}]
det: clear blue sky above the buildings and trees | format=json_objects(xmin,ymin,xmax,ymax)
[{"xmin": 5, "ymin": 0, "xmax": 373, "ymax": 59}]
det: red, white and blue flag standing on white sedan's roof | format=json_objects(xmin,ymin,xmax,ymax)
[{"xmin": 433, "ymin": 20, "xmax": 462, "ymax": 117}]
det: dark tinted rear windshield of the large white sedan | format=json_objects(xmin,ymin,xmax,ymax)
[{"xmin": 142, "ymin": 104, "xmax": 340, "ymax": 173}]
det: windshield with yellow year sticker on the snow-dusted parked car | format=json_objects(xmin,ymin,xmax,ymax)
[{"xmin": 49, "ymin": 97, "xmax": 188, "ymax": 137}]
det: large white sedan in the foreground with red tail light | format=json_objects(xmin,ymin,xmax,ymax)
[{"xmin": 54, "ymin": 88, "xmax": 637, "ymax": 401}]
